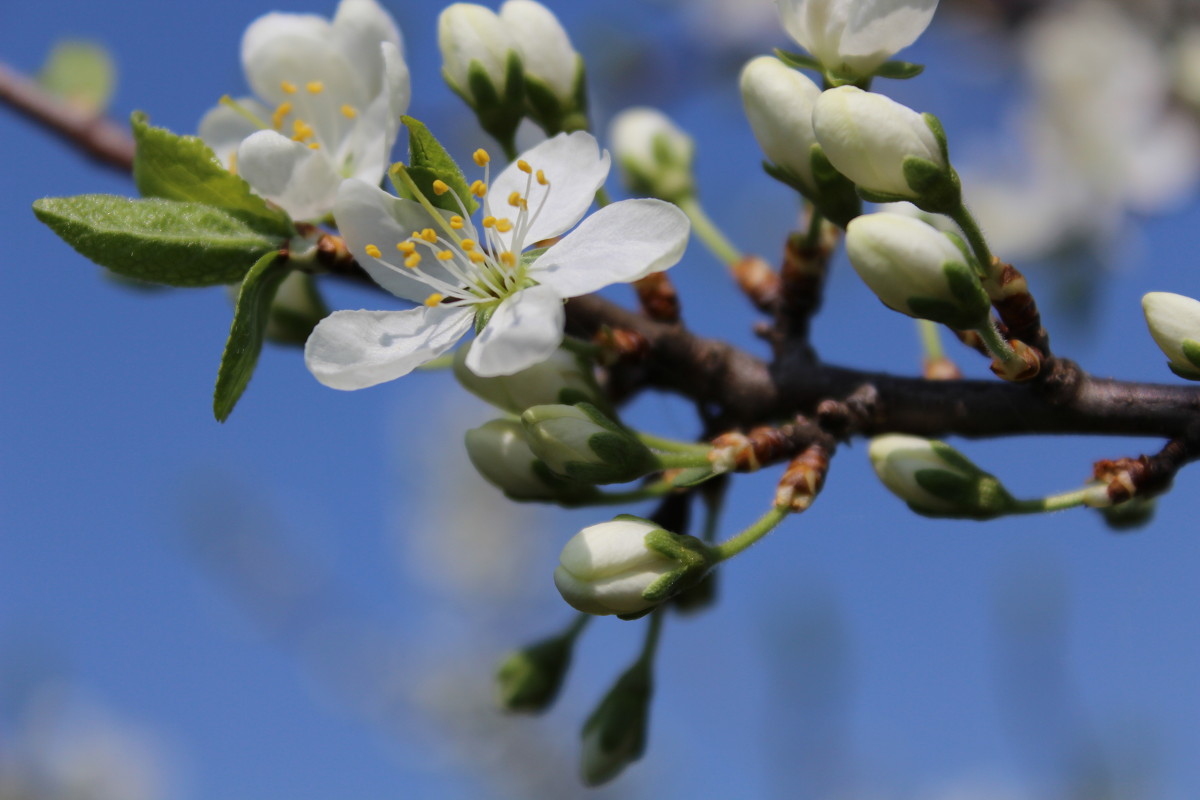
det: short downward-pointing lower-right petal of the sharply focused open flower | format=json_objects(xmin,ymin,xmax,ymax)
[{"xmin": 467, "ymin": 287, "xmax": 566, "ymax": 378}]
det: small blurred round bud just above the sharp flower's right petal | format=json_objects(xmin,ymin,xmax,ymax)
[{"xmin": 608, "ymin": 107, "xmax": 696, "ymax": 203}]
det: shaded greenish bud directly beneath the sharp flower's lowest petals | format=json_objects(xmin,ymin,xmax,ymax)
[{"xmin": 454, "ymin": 345, "xmax": 607, "ymax": 414}]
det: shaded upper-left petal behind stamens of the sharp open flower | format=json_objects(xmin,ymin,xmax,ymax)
[{"xmin": 334, "ymin": 178, "xmax": 452, "ymax": 302}]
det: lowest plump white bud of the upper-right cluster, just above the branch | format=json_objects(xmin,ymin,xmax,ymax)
[{"xmin": 846, "ymin": 213, "xmax": 991, "ymax": 330}]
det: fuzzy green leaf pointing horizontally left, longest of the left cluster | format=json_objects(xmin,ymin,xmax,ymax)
[{"xmin": 34, "ymin": 194, "xmax": 283, "ymax": 287}]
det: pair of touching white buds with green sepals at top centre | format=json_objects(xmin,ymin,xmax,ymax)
[{"xmin": 438, "ymin": 0, "xmax": 587, "ymax": 144}]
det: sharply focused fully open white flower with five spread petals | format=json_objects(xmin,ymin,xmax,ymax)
[{"xmin": 305, "ymin": 131, "xmax": 690, "ymax": 389}]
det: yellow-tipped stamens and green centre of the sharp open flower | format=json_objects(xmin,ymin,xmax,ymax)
[{"xmin": 364, "ymin": 149, "xmax": 551, "ymax": 306}]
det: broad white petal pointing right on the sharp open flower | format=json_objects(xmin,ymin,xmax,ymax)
[{"xmin": 529, "ymin": 199, "xmax": 691, "ymax": 297}]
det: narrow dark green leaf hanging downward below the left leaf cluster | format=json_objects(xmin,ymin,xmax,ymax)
[{"xmin": 212, "ymin": 251, "xmax": 292, "ymax": 422}]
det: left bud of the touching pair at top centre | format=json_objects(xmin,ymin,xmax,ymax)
[{"xmin": 438, "ymin": 2, "xmax": 524, "ymax": 142}]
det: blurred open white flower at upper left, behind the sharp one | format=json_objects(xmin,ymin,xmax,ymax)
[{"xmin": 199, "ymin": 0, "xmax": 409, "ymax": 219}]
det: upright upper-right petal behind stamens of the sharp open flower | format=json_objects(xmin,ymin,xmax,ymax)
[{"xmin": 487, "ymin": 131, "xmax": 610, "ymax": 247}]
